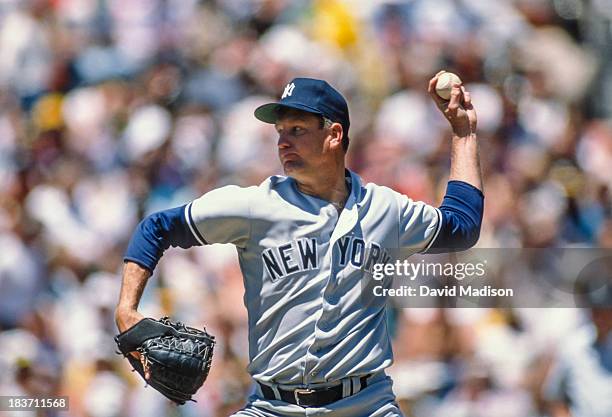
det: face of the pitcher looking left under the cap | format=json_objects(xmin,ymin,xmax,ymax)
[{"xmin": 275, "ymin": 110, "xmax": 333, "ymax": 181}]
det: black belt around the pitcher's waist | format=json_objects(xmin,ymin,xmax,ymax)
[{"xmin": 258, "ymin": 375, "xmax": 371, "ymax": 407}]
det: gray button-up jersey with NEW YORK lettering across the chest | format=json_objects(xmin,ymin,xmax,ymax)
[{"xmin": 185, "ymin": 172, "xmax": 440, "ymax": 385}]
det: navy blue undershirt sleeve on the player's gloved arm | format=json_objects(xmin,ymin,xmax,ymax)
[{"xmin": 123, "ymin": 206, "xmax": 200, "ymax": 272}]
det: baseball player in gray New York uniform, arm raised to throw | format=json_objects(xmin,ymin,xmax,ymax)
[{"xmin": 116, "ymin": 75, "xmax": 484, "ymax": 417}]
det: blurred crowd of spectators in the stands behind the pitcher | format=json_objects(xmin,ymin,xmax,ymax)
[{"xmin": 0, "ymin": 0, "xmax": 612, "ymax": 417}]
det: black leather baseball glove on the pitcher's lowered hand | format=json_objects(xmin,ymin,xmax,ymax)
[{"xmin": 115, "ymin": 317, "xmax": 215, "ymax": 405}]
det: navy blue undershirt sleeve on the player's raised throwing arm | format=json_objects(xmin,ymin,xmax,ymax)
[{"xmin": 427, "ymin": 181, "xmax": 484, "ymax": 253}]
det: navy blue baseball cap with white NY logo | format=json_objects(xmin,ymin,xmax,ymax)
[{"xmin": 255, "ymin": 78, "xmax": 351, "ymax": 138}]
